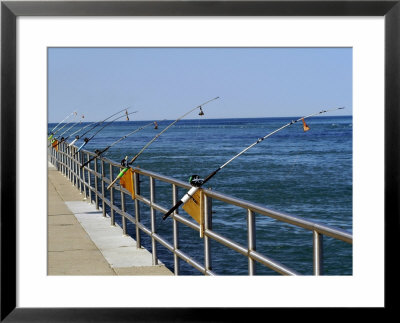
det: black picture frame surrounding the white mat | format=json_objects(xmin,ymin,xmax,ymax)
[{"xmin": 0, "ymin": 0, "xmax": 400, "ymax": 322}]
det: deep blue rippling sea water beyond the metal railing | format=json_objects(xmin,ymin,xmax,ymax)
[{"xmin": 49, "ymin": 116, "xmax": 353, "ymax": 275}]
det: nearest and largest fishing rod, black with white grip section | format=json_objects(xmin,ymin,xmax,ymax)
[{"xmin": 163, "ymin": 107, "xmax": 344, "ymax": 220}]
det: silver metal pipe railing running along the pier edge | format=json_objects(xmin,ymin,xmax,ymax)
[{"xmin": 49, "ymin": 142, "xmax": 353, "ymax": 275}]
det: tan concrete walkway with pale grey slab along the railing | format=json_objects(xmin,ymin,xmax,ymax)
[{"xmin": 48, "ymin": 163, "xmax": 173, "ymax": 275}]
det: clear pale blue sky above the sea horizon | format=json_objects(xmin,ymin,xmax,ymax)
[{"xmin": 48, "ymin": 48, "xmax": 353, "ymax": 122}]
